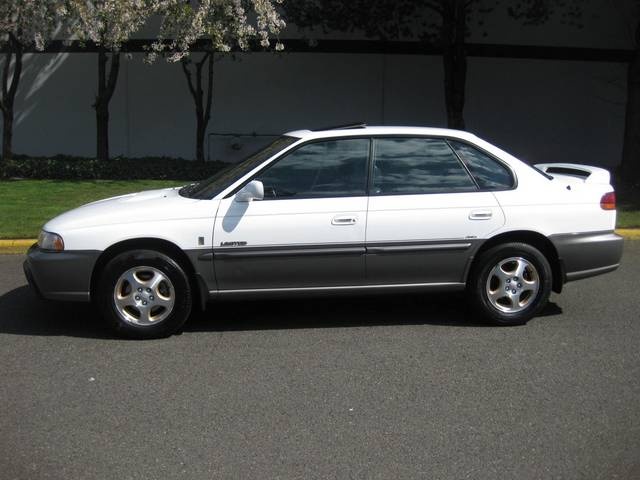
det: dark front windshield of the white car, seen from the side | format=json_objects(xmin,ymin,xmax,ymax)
[{"xmin": 179, "ymin": 136, "xmax": 299, "ymax": 200}]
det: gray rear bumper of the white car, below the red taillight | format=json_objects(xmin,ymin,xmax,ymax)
[{"xmin": 549, "ymin": 232, "xmax": 624, "ymax": 282}]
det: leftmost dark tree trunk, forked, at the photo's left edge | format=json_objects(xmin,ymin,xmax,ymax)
[{"xmin": 0, "ymin": 37, "xmax": 22, "ymax": 160}]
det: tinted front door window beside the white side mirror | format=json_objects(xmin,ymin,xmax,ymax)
[{"xmin": 256, "ymin": 139, "xmax": 369, "ymax": 199}]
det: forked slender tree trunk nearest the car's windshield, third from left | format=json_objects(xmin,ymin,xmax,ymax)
[{"xmin": 182, "ymin": 52, "xmax": 214, "ymax": 162}]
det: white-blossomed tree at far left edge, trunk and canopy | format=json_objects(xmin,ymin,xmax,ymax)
[{"xmin": 0, "ymin": 0, "xmax": 62, "ymax": 159}]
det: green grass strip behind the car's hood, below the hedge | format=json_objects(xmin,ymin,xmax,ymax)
[{"xmin": 0, "ymin": 180, "xmax": 182, "ymax": 238}]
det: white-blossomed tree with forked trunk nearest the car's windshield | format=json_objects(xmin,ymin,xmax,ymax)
[{"xmin": 147, "ymin": 0, "xmax": 285, "ymax": 161}]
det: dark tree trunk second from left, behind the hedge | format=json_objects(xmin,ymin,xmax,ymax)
[{"xmin": 93, "ymin": 49, "xmax": 120, "ymax": 160}]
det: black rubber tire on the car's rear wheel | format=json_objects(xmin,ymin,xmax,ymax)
[{"xmin": 467, "ymin": 243, "xmax": 553, "ymax": 326}]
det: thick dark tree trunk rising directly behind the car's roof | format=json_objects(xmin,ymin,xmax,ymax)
[{"xmin": 441, "ymin": 0, "xmax": 467, "ymax": 130}]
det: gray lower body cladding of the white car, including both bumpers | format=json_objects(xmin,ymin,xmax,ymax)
[{"xmin": 24, "ymin": 232, "xmax": 623, "ymax": 301}]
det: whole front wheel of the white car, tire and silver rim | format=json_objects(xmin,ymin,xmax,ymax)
[{"xmin": 97, "ymin": 250, "xmax": 192, "ymax": 339}]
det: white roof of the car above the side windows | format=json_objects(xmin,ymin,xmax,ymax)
[{"xmin": 285, "ymin": 126, "xmax": 478, "ymax": 141}]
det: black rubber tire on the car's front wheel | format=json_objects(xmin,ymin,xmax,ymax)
[{"xmin": 96, "ymin": 250, "xmax": 193, "ymax": 339}]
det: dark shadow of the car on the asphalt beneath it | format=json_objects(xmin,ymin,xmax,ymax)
[{"xmin": 0, "ymin": 286, "xmax": 562, "ymax": 339}]
